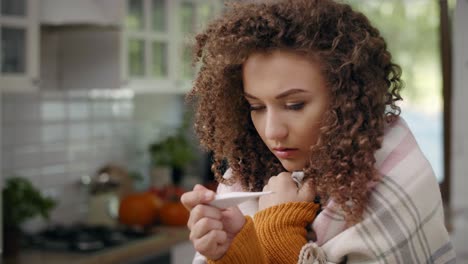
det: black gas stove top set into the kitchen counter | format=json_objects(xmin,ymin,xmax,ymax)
[{"xmin": 28, "ymin": 224, "xmax": 150, "ymax": 253}]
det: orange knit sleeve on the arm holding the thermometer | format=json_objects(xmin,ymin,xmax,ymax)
[{"xmin": 207, "ymin": 216, "xmax": 267, "ymax": 264}]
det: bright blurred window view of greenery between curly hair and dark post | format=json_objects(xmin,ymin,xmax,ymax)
[{"xmin": 347, "ymin": 0, "xmax": 454, "ymax": 182}]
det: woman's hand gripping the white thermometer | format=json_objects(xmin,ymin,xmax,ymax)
[{"xmin": 181, "ymin": 184, "xmax": 245, "ymax": 260}]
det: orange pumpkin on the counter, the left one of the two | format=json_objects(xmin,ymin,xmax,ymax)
[{"xmin": 119, "ymin": 192, "xmax": 162, "ymax": 226}]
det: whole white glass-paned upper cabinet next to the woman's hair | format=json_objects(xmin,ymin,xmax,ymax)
[{"xmin": 121, "ymin": 0, "xmax": 222, "ymax": 93}]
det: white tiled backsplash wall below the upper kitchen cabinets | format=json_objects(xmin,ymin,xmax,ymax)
[{"xmin": 0, "ymin": 90, "xmax": 186, "ymax": 230}]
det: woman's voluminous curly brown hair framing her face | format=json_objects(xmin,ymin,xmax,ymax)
[{"xmin": 188, "ymin": 0, "xmax": 403, "ymax": 223}]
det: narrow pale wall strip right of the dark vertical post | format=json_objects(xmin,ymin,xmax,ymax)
[{"xmin": 450, "ymin": 0, "xmax": 468, "ymax": 258}]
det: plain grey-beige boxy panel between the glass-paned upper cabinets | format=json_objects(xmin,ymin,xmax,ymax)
[{"xmin": 40, "ymin": 25, "xmax": 122, "ymax": 90}]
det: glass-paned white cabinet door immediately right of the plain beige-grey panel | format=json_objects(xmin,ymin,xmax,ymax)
[{"xmin": 121, "ymin": 0, "xmax": 176, "ymax": 92}]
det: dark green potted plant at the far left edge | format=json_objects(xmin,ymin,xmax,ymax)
[{"xmin": 2, "ymin": 176, "xmax": 56, "ymax": 256}]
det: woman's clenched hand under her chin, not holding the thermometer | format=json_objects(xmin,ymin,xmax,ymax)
[{"xmin": 258, "ymin": 172, "xmax": 314, "ymax": 210}]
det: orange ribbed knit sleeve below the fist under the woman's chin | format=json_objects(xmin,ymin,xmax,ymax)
[{"xmin": 254, "ymin": 202, "xmax": 319, "ymax": 263}]
